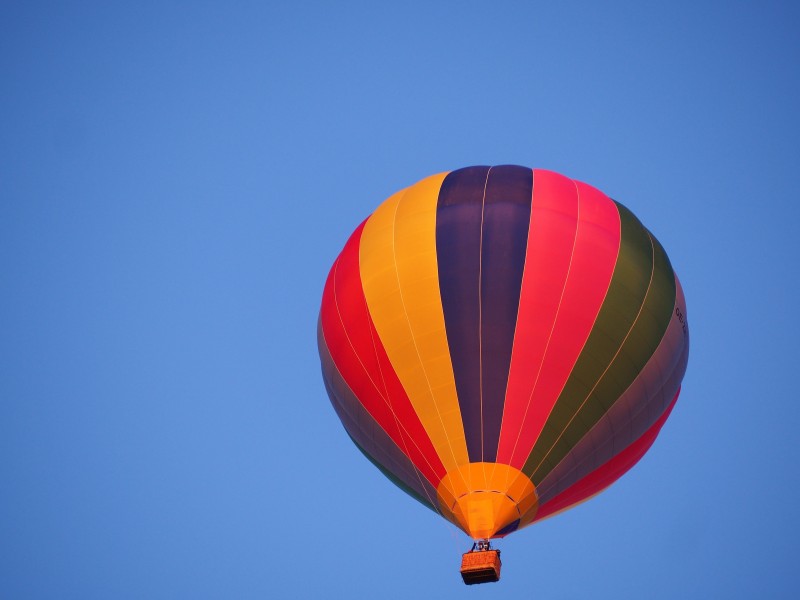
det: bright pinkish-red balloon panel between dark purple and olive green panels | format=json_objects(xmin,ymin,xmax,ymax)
[{"xmin": 497, "ymin": 169, "xmax": 620, "ymax": 469}]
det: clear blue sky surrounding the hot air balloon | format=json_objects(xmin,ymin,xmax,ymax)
[{"xmin": 0, "ymin": 0, "xmax": 800, "ymax": 600}]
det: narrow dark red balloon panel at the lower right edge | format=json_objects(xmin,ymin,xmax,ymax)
[{"xmin": 534, "ymin": 389, "xmax": 681, "ymax": 522}]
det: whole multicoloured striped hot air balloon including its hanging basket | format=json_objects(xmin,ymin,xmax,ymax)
[{"xmin": 318, "ymin": 165, "xmax": 689, "ymax": 583}]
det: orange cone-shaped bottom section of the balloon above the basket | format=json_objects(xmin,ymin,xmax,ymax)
[{"xmin": 437, "ymin": 462, "xmax": 539, "ymax": 540}]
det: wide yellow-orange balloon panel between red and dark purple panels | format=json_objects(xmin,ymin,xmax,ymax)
[{"xmin": 359, "ymin": 173, "xmax": 469, "ymax": 471}]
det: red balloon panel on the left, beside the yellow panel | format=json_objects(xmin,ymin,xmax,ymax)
[{"xmin": 320, "ymin": 221, "xmax": 445, "ymax": 487}]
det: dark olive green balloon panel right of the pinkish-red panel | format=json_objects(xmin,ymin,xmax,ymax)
[{"xmin": 522, "ymin": 203, "xmax": 676, "ymax": 485}]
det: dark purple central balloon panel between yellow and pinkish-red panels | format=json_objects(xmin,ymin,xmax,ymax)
[{"xmin": 436, "ymin": 166, "xmax": 533, "ymax": 462}]
